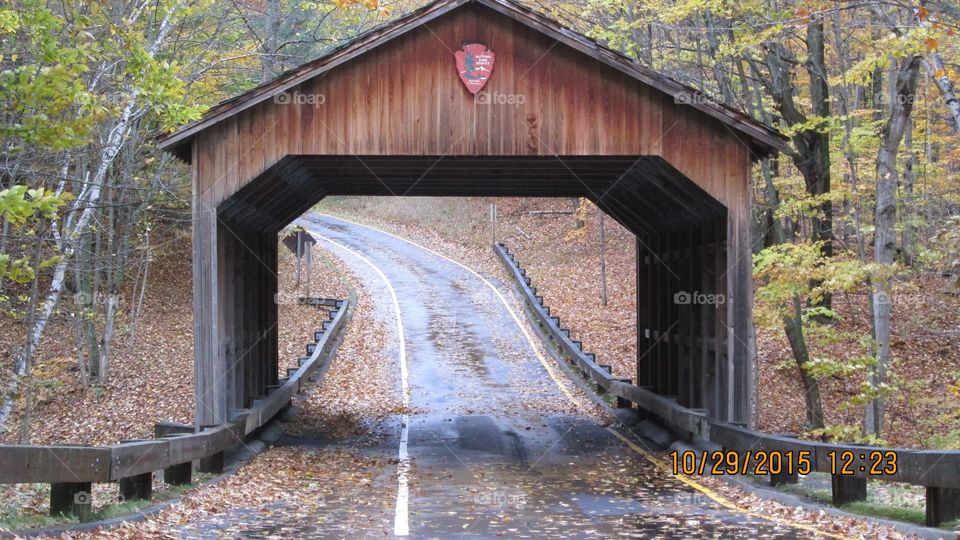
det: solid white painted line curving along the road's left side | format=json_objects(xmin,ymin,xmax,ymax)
[{"xmin": 314, "ymin": 233, "xmax": 410, "ymax": 536}]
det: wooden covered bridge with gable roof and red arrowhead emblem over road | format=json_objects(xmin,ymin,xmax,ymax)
[{"xmin": 161, "ymin": 0, "xmax": 785, "ymax": 425}]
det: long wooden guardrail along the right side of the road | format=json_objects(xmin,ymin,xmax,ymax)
[{"xmin": 494, "ymin": 244, "xmax": 960, "ymax": 526}]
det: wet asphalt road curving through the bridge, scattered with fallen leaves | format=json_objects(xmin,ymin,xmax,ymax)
[{"xmin": 299, "ymin": 214, "xmax": 809, "ymax": 538}]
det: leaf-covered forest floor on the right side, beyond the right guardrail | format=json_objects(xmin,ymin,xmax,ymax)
[{"xmin": 319, "ymin": 197, "xmax": 960, "ymax": 448}]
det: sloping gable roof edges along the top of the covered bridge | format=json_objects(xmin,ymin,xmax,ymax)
[{"xmin": 159, "ymin": 0, "xmax": 791, "ymax": 162}]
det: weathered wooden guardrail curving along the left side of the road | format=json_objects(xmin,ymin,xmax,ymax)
[{"xmin": 0, "ymin": 300, "xmax": 349, "ymax": 520}]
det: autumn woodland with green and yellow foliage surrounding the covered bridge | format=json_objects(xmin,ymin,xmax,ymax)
[{"xmin": 0, "ymin": 0, "xmax": 960, "ymax": 448}]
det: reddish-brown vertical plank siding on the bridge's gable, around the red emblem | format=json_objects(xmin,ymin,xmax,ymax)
[{"xmin": 194, "ymin": 4, "xmax": 749, "ymax": 211}]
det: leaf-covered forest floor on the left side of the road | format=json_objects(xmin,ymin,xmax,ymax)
[{"xmin": 0, "ymin": 226, "xmax": 347, "ymax": 523}]
